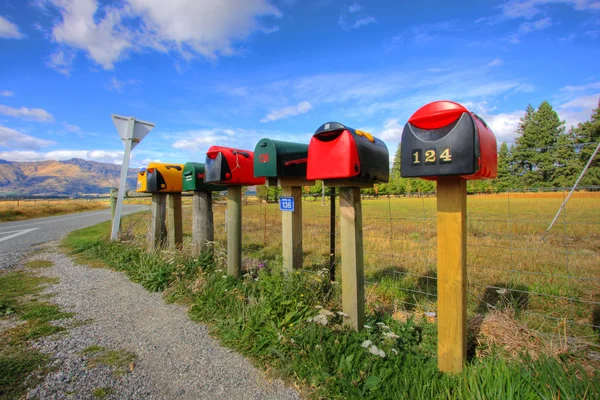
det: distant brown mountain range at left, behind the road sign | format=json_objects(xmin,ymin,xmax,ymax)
[{"xmin": 0, "ymin": 158, "xmax": 139, "ymax": 196}]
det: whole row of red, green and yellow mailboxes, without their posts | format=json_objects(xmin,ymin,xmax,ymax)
[{"xmin": 137, "ymin": 101, "xmax": 497, "ymax": 193}]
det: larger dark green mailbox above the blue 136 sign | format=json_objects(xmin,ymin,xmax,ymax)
[{"xmin": 254, "ymin": 138, "xmax": 308, "ymax": 179}]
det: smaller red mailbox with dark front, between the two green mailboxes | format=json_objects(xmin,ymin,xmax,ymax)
[{"xmin": 204, "ymin": 146, "xmax": 265, "ymax": 186}]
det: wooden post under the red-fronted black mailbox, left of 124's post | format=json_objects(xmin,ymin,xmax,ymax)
[{"xmin": 340, "ymin": 187, "xmax": 365, "ymax": 330}]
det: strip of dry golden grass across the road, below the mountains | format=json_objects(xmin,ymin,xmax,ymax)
[{"xmin": 0, "ymin": 199, "xmax": 109, "ymax": 222}]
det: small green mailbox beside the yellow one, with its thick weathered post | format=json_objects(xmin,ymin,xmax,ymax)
[{"xmin": 182, "ymin": 162, "xmax": 227, "ymax": 257}]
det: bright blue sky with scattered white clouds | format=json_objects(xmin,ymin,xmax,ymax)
[{"xmin": 0, "ymin": 0, "xmax": 600, "ymax": 166}]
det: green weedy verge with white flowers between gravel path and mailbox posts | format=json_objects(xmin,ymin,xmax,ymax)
[{"xmin": 65, "ymin": 224, "xmax": 600, "ymax": 399}]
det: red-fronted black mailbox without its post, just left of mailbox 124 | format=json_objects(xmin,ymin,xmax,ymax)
[{"xmin": 306, "ymin": 122, "xmax": 390, "ymax": 183}]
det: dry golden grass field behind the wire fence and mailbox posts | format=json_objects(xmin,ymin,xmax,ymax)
[{"xmin": 118, "ymin": 192, "xmax": 600, "ymax": 341}]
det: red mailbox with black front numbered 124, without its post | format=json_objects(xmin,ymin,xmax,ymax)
[{"xmin": 401, "ymin": 100, "xmax": 498, "ymax": 179}]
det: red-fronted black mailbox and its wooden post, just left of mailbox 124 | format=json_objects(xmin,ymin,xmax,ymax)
[{"xmin": 306, "ymin": 122, "xmax": 390, "ymax": 330}]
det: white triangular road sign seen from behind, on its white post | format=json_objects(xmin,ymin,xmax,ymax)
[{"xmin": 110, "ymin": 114, "xmax": 154, "ymax": 240}]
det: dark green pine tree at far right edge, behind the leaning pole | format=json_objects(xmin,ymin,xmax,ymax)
[{"xmin": 573, "ymin": 100, "xmax": 600, "ymax": 186}]
